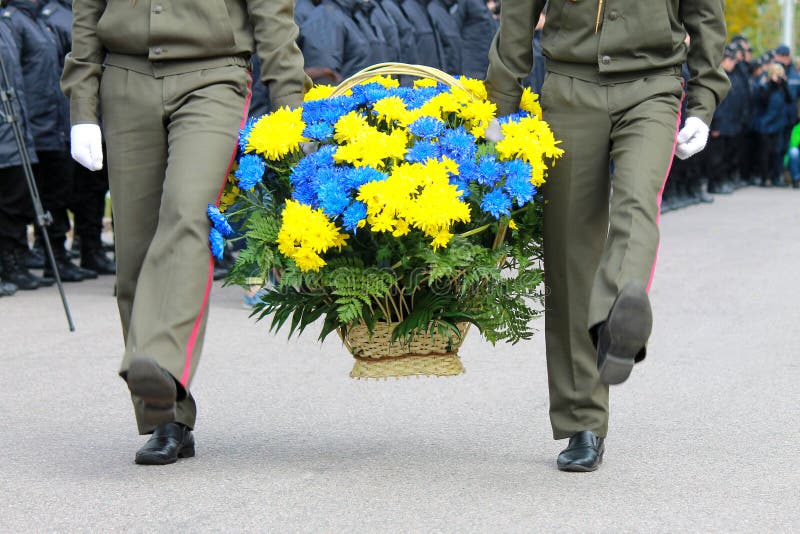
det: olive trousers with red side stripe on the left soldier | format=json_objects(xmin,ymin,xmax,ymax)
[{"xmin": 100, "ymin": 62, "xmax": 250, "ymax": 434}]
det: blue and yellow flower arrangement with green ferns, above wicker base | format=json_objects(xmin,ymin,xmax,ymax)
[{"xmin": 208, "ymin": 69, "xmax": 562, "ymax": 376}]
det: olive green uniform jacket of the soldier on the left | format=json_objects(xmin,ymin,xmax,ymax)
[{"xmin": 61, "ymin": 0, "xmax": 311, "ymax": 124}]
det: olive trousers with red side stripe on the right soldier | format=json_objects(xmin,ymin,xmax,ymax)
[{"xmin": 542, "ymin": 73, "xmax": 683, "ymax": 439}]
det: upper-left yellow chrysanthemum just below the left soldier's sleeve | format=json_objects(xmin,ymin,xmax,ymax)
[{"xmin": 245, "ymin": 107, "xmax": 308, "ymax": 161}]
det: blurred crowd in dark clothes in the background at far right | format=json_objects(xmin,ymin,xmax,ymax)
[{"xmin": 662, "ymin": 35, "xmax": 800, "ymax": 212}]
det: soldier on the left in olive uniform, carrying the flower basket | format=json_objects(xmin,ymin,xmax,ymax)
[{"xmin": 62, "ymin": 0, "xmax": 310, "ymax": 464}]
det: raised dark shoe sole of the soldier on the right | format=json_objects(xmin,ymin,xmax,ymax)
[{"xmin": 598, "ymin": 282, "xmax": 653, "ymax": 385}]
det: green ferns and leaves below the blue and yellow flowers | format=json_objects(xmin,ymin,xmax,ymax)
[{"xmin": 227, "ymin": 178, "xmax": 543, "ymax": 350}]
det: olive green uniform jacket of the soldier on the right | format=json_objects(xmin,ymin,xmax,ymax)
[{"xmin": 487, "ymin": 0, "xmax": 730, "ymax": 124}]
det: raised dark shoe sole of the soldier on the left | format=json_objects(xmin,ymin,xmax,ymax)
[{"xmin": 126, "ymin": 357, "xmax": 177, "ymax": 426}]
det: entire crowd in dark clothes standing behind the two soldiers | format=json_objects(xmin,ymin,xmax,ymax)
[{"xmin": 0, "ymin": 0, "xmax": 800, "ymax": 302}]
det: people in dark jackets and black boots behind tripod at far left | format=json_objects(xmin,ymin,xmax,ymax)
[{"xmin": 0, "ymin": 0, "xmax": 115, "ymax": 302}]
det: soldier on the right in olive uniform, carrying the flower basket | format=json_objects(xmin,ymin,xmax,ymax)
[{"xmin": 486, "ymin": 0, "xmax": 729, "ymax": 471}]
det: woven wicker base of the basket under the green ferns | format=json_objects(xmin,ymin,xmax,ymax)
[{"xmin": 339, "ymin": 323, "xmax": 469, "ymax": 379}]
